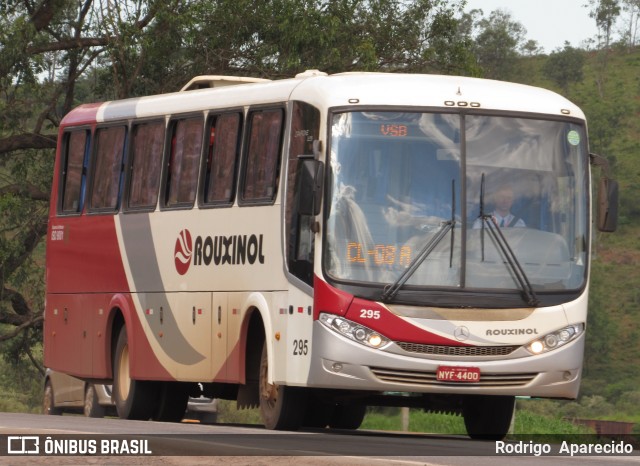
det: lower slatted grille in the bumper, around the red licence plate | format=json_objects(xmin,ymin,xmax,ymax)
[{"xmin": 371, "ymin": 367, "xmax": 538, "ymax": 387}]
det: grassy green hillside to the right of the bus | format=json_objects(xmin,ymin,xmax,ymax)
[{"xmin": 521, "ymin": 47, "xmax": 640, "ymax": 414}]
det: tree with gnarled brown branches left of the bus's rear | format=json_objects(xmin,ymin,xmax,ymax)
[{"xmin": 0, "ymin": 0, "xmax": 178, "ymax": 370}]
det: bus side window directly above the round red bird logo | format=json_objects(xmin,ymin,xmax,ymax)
[{"xmin": 164, "ymin": 117, "xmax": 203, "ymax": 208}]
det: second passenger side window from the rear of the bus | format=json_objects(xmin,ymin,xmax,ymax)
[{"xmin": 90, "ymin": 126, "xmax": 127, "ymax": 212}]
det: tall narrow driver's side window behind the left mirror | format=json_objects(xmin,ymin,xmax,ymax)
[{"xmin": 285, "ymin": 101, "xmax": 320, "ymax": 286}]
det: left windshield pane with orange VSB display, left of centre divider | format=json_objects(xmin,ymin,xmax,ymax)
[{"xmin": 326, "ymin": 112, "xmax": 461, "ymax": 286}]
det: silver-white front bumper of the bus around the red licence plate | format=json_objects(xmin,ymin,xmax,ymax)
[{"xmin": 308, "ymin": 321, "xmax": 584, "ymax": 399}]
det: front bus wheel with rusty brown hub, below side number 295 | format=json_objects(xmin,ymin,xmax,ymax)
[{"xmin": 259, "ymin": 343, "xmax": 307, "ymax": 430}]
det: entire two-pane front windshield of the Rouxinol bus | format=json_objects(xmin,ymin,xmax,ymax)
[{"xmin": 324, "ymin": 111, "xmax": 589, "ymax": 300}]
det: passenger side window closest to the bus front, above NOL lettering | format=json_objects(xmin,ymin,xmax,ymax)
[{"xmin": 240, "ymin": 108, "xmax": 284, "ymax": 204}]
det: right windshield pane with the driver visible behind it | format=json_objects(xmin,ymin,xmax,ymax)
[{"xmin": 465, "ymin": 115, "xmax": 587, "ymax": 290}]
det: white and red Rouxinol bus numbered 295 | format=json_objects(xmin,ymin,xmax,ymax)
[{"xmin": 44, "ymin": 71, "xmax": 617, "ymax": 438}]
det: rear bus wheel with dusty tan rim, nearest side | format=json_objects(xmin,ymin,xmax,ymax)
[{"xmin": 113, "ymin": 327, "xmax": 158, "ymax": 421}]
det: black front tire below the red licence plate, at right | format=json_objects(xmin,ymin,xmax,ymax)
[{"xmin": 462, "ymin": 395, "xmax": 516, "ymax": 441}]
